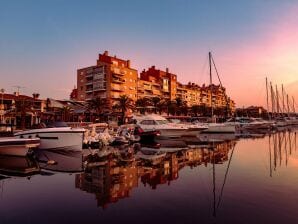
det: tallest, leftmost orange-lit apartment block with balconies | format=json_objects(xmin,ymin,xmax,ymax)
[{"xmin": 77, "ymin": 51, "xmax": 138, "ymax": 108}]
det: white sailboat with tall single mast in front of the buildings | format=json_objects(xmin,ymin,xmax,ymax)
[{"xmin": 202, "ymin": 52, "xmax": 236, "ymax": 134}]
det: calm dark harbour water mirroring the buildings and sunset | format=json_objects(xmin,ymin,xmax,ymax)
[{"xmin": 0, "ymin": 130, "xmax": 298, "ymax": 224}]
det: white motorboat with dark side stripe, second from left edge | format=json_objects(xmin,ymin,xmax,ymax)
[{"xmin": 14, "ymin": 127, "xmax": 85, "ymax": 151}]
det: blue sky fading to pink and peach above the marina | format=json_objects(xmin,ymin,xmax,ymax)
[{"xmin": 0, "ymin": 0, "xmax": 298, "ymax": 107}]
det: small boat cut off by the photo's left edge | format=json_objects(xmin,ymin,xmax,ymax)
[{"xmin": 0, "ymin": 138, "xmax": 40, "ymax": 156}]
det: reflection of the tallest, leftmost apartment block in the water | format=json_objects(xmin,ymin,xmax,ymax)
[{"xmin": 75, "ymin": 153, "xmax": 139, "ymax": 208}]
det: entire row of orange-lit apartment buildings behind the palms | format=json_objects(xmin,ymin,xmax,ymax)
[{"xmin": 75, "ymin": 51, "xmax": 235, "ymax": 112}]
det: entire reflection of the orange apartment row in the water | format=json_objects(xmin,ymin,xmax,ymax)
[{"xmin": 75, "ymin": 141, "xmax": 236, "ymax": 208}]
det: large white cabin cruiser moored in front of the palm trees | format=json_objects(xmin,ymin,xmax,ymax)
[{"xmin": 133, "ymin": 114, "xmax": 206, "ymax": 138}]
